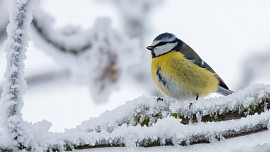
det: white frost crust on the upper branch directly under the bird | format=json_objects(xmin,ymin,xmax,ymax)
[{"xmin": 77, "ymin": 84, "xmax": 269, "ymax": 134}]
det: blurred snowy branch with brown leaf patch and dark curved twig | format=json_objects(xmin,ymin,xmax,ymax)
[{"xmin": 32, "ymin": 10, "xmax": 139, "ymax": 103}]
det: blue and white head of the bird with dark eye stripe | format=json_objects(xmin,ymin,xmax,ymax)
[{"xmin": 146, "ymin": 33, "xmax": 179, "ymax": 58}]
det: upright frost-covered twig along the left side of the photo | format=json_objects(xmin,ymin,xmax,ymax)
[{"xmin": 1, "ymin": 0, "xmax": 35, "ymax": 151}]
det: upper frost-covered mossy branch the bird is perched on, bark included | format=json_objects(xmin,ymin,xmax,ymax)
[{"xmin": 74, "ymin": 84, "xmax": 270, "ymax": 132}]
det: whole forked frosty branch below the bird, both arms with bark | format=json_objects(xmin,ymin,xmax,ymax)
[{"xmin": 0, "ymin": 84, "xmax": 270, "ymax": 151}]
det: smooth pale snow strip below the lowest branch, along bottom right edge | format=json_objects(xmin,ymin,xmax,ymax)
[{"xmin": 73, "ymin": 131, "xmax": 270, "ymax": 152}]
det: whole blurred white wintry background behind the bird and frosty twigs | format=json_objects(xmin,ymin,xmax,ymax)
[{"xmin": 0, "ymin": 0, "xmax": 270, "ymax": 132}]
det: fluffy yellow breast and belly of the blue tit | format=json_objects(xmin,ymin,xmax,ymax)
[{"xmin": 151, "ymin": 51, "xmax": 219, "ymax": 98}]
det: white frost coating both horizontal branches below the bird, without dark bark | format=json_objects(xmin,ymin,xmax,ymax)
[{"xmin": 0, "ymin": 84, "xmax": 270, "ymax": 150}]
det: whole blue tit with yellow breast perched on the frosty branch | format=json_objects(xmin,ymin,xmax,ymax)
[{"xmin": 146, "ymin": 33, "xmax": 233, "ymax": 100}]
